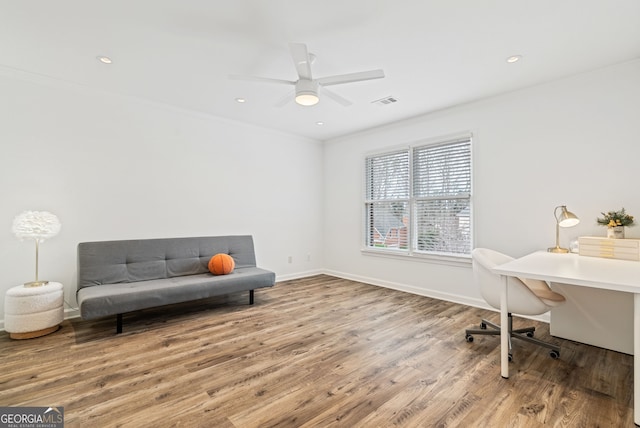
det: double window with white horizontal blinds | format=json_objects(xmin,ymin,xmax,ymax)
[{"xmin": 365, "ymin": 136, "xmax": 471, "ymax": 255}]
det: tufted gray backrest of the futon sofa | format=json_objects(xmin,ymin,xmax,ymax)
[{"xmin": 78, "ymin": 235, "xmax": 256, "ymax": 289}]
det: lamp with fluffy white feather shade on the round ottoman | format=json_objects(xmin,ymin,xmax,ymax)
[{"xmin": 12, "ymin": 211, "xmax": 62, "ymax": 287}]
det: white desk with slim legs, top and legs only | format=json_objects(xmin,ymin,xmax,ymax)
[{"xmin": 493, "ymin": 251, "xmax": 640, "ymax": 425}]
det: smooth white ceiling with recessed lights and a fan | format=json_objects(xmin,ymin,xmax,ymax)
[{"xmin": 0, "ymin": 0, "xmax": 640, "ymax": 140}]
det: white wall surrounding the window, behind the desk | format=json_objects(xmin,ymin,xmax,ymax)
[{"xmin": 324, "ymin": 60, "xmax": 640, "ymax": 305}]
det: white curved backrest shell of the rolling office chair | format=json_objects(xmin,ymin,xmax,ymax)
[{"xmin": 471, "ymin": 248, "xmax": 551, "ymax": 315}]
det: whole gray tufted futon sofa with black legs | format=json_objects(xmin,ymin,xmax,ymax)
[{"xmin": 77, "ymin": 236, "xmax": 275, "ymax": 333}]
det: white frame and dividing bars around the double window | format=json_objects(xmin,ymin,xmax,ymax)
[{"xmin": 360, "ymin": 132, "xmax": 474, "ymax": 265}]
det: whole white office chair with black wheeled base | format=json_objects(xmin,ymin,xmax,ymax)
[{"xmin": 465, "ymin": 248, "xmax": 565, "ymax": 361}]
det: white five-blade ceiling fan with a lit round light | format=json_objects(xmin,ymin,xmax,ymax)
[{"xmin": 229, "ymin": 43, "xmax": 384, "ymax": 106}]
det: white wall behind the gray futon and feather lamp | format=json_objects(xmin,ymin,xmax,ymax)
[{"xmin": 0, "ymin": 70, "xmax": 323, "ymax": 319}]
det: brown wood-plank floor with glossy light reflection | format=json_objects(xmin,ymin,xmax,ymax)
[{"xmin": 0, "ymin": 275, "xmax": 634, "ymax": 428}]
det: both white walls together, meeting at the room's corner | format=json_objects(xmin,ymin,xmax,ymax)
[{"xmin": 0, "ymin": 61, "xmax": 640, "ymax": 328}]
